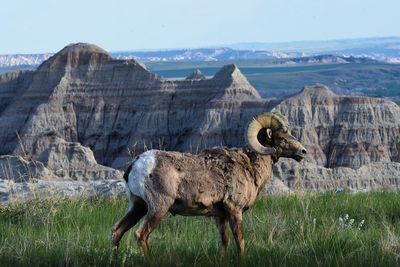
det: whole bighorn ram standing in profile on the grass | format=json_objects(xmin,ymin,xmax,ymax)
[{"xmin": 112, "ymin": 112, "xmax": 307, "ymax": 255}]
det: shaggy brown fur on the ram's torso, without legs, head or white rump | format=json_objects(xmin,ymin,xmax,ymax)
[{"xmin": 146, "ymin": 148, "xmax": 272, "ymax": 216}]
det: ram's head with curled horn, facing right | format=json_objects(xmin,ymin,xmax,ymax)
[{"xmin": 246, "ymin": 112, "xmax": 307, "ymax": 161}]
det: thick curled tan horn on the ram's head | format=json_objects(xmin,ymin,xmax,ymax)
[{"xmin": 246, "ymin": 112, "xmax": 288, "ymax": 155}]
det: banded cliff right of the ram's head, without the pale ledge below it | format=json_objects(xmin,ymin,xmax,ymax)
[{"xmin": 275, "ymin": 86, "xmax": 400, "ymax": 169}]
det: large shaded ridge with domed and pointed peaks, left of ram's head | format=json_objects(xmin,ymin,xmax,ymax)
[{"xmin": 0, "ymin": 44, "xmax": 275, "ymax": 171}]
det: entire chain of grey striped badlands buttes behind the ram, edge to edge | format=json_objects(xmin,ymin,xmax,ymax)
[{"xmin": 0, "ymin": 43, "xmax": 400, "ymax": 200}]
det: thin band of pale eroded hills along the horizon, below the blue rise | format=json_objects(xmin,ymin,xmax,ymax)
[{"xmin": 0, "ymin": 48, "xmax": 385, "ymax": 69}]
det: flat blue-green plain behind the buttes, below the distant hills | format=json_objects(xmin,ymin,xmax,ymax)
[{"xmin": 147, "ymin": 61, "xmax": 400, "ymax": 99}]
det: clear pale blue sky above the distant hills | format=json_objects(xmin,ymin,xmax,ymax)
[{"xmin": 0, "ymin": 0, "xmax": 400, "ymax": 54}]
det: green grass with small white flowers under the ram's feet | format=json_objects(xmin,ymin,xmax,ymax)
[{"xmin": 0, "ymin": 192, "xmax": 400, "ymax": 266}]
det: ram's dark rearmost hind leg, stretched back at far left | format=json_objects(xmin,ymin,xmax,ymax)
[{"xmin": 112, "ymin": 199, "xmax": 147, "ymax": 248}]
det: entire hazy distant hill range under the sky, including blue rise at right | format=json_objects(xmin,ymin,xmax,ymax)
[{"xmin": 0, "ymin": 37, "xmax": 400, "ymax": 68}]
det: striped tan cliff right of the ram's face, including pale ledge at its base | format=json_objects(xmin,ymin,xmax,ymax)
[{"xmin": 274, "ymin": 86, "xmax": 400, "ymax": 191}]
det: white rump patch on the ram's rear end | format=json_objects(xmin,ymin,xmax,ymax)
[{"xmin": 127, "ymin": 150, "xmax": 157, "ymax": 201}]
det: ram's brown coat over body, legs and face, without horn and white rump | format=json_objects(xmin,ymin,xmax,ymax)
[{"xmin": 112, "ymin": 130, "xmax": 306, "ymax": 260}]
